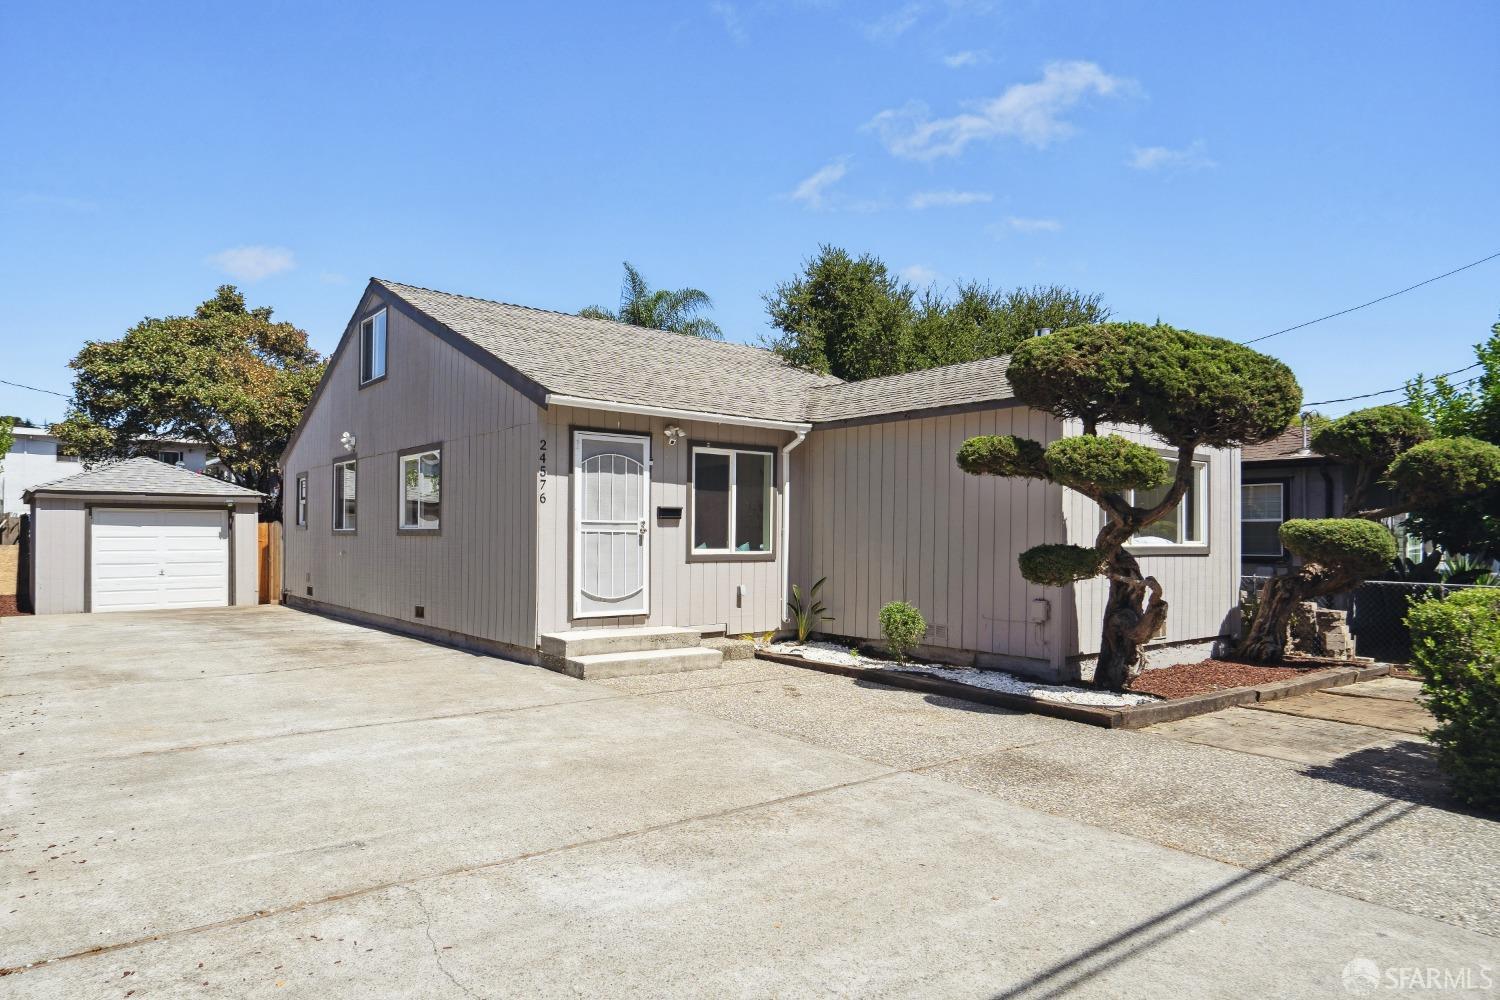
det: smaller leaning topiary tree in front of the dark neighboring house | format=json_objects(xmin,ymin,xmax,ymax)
[{"xmin": 1236, "ymin": 406, "xmax": 1500, "ymax": 663}]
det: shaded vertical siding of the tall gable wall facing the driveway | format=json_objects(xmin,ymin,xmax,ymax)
[{"xmin": 285, "ymin": 294, "xmax": 539, "ymax": 648}]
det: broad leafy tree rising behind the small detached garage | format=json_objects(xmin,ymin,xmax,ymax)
[{"xmin": 53, "ymin": 285, "xmax": 324, "ymax": 517}]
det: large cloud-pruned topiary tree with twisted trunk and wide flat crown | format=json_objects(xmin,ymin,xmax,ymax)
[{"xmin": 959, "ymin": 322, "xmax": 1302, "ymax": 691}]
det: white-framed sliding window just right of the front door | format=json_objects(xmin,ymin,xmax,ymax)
[{"xmin": 692, "ymin": 445, "xmax": 776, "ymax": 556}]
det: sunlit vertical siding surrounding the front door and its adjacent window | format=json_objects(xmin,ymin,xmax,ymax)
[{"xmin": 534, "ymin": 406, "xmax": 807, "ymax": 634}]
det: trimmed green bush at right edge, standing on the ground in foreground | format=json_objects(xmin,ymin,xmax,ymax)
[{"xmin": 1407, "ymin": 588, "xmax": 1500, "ymax": 810}]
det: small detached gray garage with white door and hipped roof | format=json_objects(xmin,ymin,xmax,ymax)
[{"xmin": 24, "ymin": 459, "xmax": 261, "ymax": 615}]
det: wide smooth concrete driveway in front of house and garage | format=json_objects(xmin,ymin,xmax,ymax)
[{"xmin": 0, "ymin": 607, "xmax": 1497, "ymax": 999}]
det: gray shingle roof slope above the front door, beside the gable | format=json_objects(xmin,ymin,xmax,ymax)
[{"xmin": 375, "ymin": 279, "xmax": 839, "ymax": 420}]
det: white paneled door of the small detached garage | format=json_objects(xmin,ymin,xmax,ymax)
[{"xmin": 90, "ymin": 507, "xmax": 230, "ymax": 612}]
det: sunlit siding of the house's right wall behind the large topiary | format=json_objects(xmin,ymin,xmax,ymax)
[{"xmin": 1064, "ymin": 421, "xmax": 1239, "ymax": 655}]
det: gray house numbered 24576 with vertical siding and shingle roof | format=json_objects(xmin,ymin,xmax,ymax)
[{"xmin": 282, "ymin": 279, "xmax": 1239, "ymax": 689}]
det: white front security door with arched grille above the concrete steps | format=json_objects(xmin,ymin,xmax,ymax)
[{"xmin": 572, "ymin": 430, "xmax": 651, "ymax": 618}]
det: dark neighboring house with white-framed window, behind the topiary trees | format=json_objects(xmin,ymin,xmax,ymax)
[{"xmin": 1239, "ymin": 417, "xmax": 1424, "ymax": 576}]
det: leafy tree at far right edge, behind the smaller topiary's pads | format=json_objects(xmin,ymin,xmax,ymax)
[{"xmin": 1407, "ymin": 322, "xmax": 1500, "ymax": 559}]
